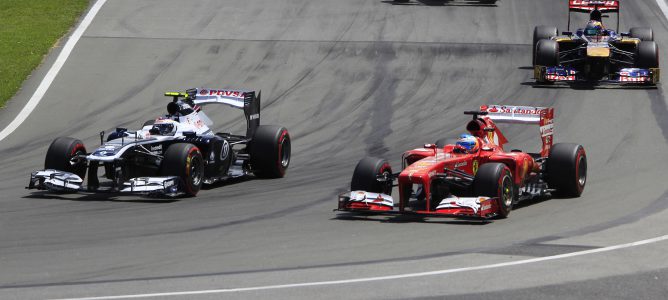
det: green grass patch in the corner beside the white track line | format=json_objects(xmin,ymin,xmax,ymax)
[{"xmin": 0, "ymin": 0, "xmax": 89, "ymax": 107}]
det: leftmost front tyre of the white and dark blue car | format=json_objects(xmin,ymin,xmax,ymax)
[{"xmin": 44, "ymin": 137, "xmax": 86, "ymax": 179}]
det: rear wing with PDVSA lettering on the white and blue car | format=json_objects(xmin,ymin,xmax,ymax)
[{"xmin": 165, "ymin": 88, "xmax": 261, "ymax": 138}]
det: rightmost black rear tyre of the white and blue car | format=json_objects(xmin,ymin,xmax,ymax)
[{"xmin": 248, "ymin": 125, "xmax": 291, "ymax": 178}]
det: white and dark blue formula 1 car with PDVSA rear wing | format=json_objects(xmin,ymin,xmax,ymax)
[{"xmin": 27, "ymin": 89, "xmax": 290, "ymax": 197}]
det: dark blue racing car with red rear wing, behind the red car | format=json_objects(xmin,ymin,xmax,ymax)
[{"xmin": 532, "ymin": 0, "xmax": 660, "ymax": 86}]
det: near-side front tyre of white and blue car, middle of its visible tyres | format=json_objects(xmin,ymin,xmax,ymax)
[{"xmin": 160, "ymin": 143, "xmax": 204, "ymax": 196}]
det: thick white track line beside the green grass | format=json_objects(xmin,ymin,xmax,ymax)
[{"xmin": 0, "ymin": 0, "xmax": 107, "ymax": 141}]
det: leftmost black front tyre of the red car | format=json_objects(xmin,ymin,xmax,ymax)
[{"xmin": 350, "ymin": 157, "xmax": 392, "ymax": 195}]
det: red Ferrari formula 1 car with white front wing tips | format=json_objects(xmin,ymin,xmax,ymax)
[{"xmin": 337, "ymin": 105, "xmax": 587, "ymax": 219}]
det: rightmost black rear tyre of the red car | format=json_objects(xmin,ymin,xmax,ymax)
[{"xmin": 547, "ymin": 143, "xmax": 587, "ymax": 197}]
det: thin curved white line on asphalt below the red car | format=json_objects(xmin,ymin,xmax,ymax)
[{"xmin": 51, "ymin": 235, "xmax": 668, "ymax": 300}]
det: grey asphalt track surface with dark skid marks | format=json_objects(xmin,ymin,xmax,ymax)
[{"xmin": 0, "ymin": 0, "xmax": 668, "ymax": 299}]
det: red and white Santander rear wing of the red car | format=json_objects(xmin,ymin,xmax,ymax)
[{"xmin": 480, "ymin": 105, "xmax": 554, "ymax": 157}]
